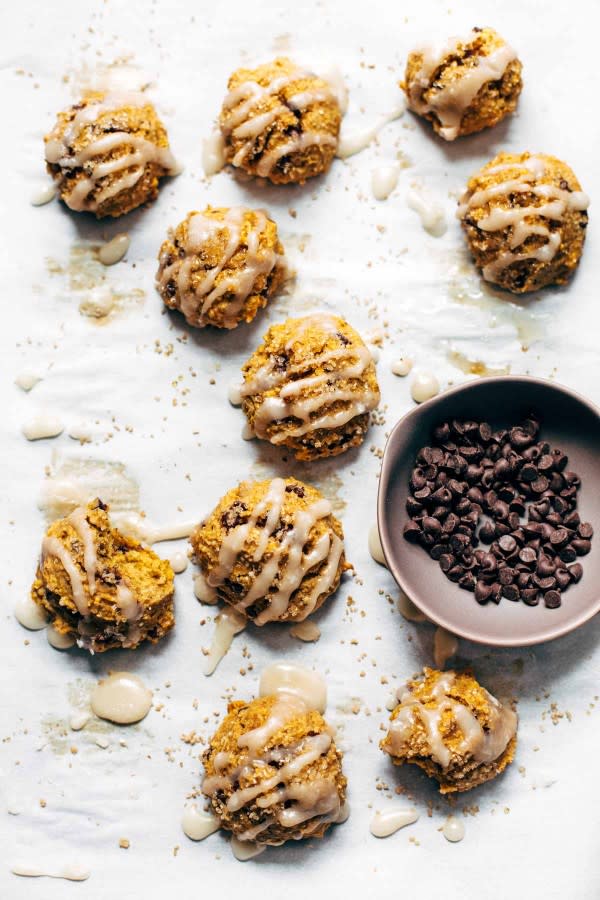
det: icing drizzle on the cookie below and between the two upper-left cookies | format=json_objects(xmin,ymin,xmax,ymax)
[{"xmin": 157, "ymin": 206, "xmax": 283, "ymax": 328}]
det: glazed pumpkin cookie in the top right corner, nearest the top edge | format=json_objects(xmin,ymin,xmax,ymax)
[{"xmin": 401, "ymin": 28, "xmax": 523, "ymax": 141}]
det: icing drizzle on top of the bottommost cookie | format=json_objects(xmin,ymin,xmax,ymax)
[{"xmin": 202, "ymin": 692, "xmax": 342, "ymax": 843}]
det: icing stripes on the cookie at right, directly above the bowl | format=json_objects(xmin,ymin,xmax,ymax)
[{"xmin": 457, "ymin": 156, "xmax": 589, "ymax": 283}]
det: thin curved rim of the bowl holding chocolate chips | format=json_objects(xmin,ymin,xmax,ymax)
[{"xmin": 377, "ymin": 375, "xmax": 600, "ymax": 647}]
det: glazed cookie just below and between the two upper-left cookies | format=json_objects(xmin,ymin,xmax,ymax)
[{"xmin": 156, "ymin": 206, "xmax": 286, "ymax": 328}]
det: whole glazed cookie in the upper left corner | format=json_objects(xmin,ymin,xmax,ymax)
[{"xmin": 44, "ymin": 93, "xmax": 178, "ymax": 219}]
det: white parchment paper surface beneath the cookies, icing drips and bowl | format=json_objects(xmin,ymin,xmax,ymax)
[{"xmin": 0, "ymin": 0, "xmax": 600, "ymax": 900}]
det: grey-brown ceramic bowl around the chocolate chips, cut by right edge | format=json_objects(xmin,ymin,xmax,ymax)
[{"xmin": 377, "ymin": 376, "xmax": 600, "ymax": 647}]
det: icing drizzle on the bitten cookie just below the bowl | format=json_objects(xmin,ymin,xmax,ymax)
[{"xmin": 388, "ymin": 672, "xmax": 517, "ymax": 769}]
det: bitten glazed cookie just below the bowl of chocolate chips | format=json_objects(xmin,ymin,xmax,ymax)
[{"xmin": 381, "ymin": 668, "xmax": 517, "ymax": 794}]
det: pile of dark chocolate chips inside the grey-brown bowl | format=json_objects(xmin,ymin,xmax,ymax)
[{"xmin": 404, "ymin": 415, "xmax": 593, "ymax": 609}]
